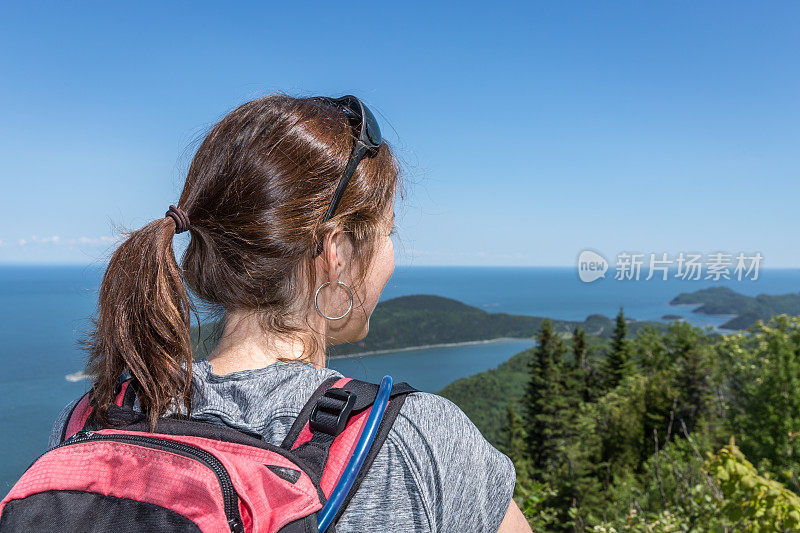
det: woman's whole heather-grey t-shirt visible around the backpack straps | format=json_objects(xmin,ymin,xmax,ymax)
[{"xmin": 50, "ymin": 360, "xmax": 516, "ymax": 533}]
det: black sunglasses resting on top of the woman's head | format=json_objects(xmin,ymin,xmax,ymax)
[{"xmin": 312, "ymin": 94, "xmax": 383, "ymax": 257}]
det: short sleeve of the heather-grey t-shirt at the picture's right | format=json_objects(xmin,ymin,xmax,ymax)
[{"xmin": 396, "ymin": 393, "xmax": 516, "ymax": 533}]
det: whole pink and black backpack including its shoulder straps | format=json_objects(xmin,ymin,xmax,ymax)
[{"xmin": 0, "ymin": 377, "xmax": 416, "ymax": 533}]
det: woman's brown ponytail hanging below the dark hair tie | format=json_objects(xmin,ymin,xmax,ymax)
[{"xmin": 82, "ymin": 210, "xmax": 194, "ymax": 431}]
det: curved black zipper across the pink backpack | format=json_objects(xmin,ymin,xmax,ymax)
[{"xmin": 52, "ymin": 430, "xmax": 244, "ymax": 533}]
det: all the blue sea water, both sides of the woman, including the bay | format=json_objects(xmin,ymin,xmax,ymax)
[{"xmin": 0, "ymin": 266, "xmax": 800, "ymax": 495}]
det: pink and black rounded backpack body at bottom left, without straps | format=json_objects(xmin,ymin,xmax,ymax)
[{"xmin": 0, "ymin": 429, "xmax": 322, "ymax": 533}]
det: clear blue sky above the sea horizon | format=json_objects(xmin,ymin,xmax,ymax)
[{"xmin": 0, "ymin": 1, "xmax": 800, "ymax": 267}]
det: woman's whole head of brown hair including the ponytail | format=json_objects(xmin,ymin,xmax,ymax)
[{"xmin": 82, "ymin": 93, "xmax": 403, "ymax": 429}]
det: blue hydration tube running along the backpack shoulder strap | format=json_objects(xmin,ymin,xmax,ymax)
[{"xmin": 317, "ymin": 376, "xmax": 392, "ymax": 533}]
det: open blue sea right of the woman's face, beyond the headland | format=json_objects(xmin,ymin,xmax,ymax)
[{"xmin": 381, "ymin": 266, "xmax": 800, "ymax": 327}]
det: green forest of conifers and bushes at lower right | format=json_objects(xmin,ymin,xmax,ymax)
[{"xmin": 440, "ymin": 309, "xmax": 800, "ymax": 532}]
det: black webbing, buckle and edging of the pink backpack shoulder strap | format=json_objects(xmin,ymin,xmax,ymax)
[{"xmin": 281, "ymin": 377, "xmax": 419, "ymax": 524}]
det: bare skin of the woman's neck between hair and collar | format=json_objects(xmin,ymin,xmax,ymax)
[{"xmin": 207, "ymin": 311, "xmax": 325, "ymax": 375}]
